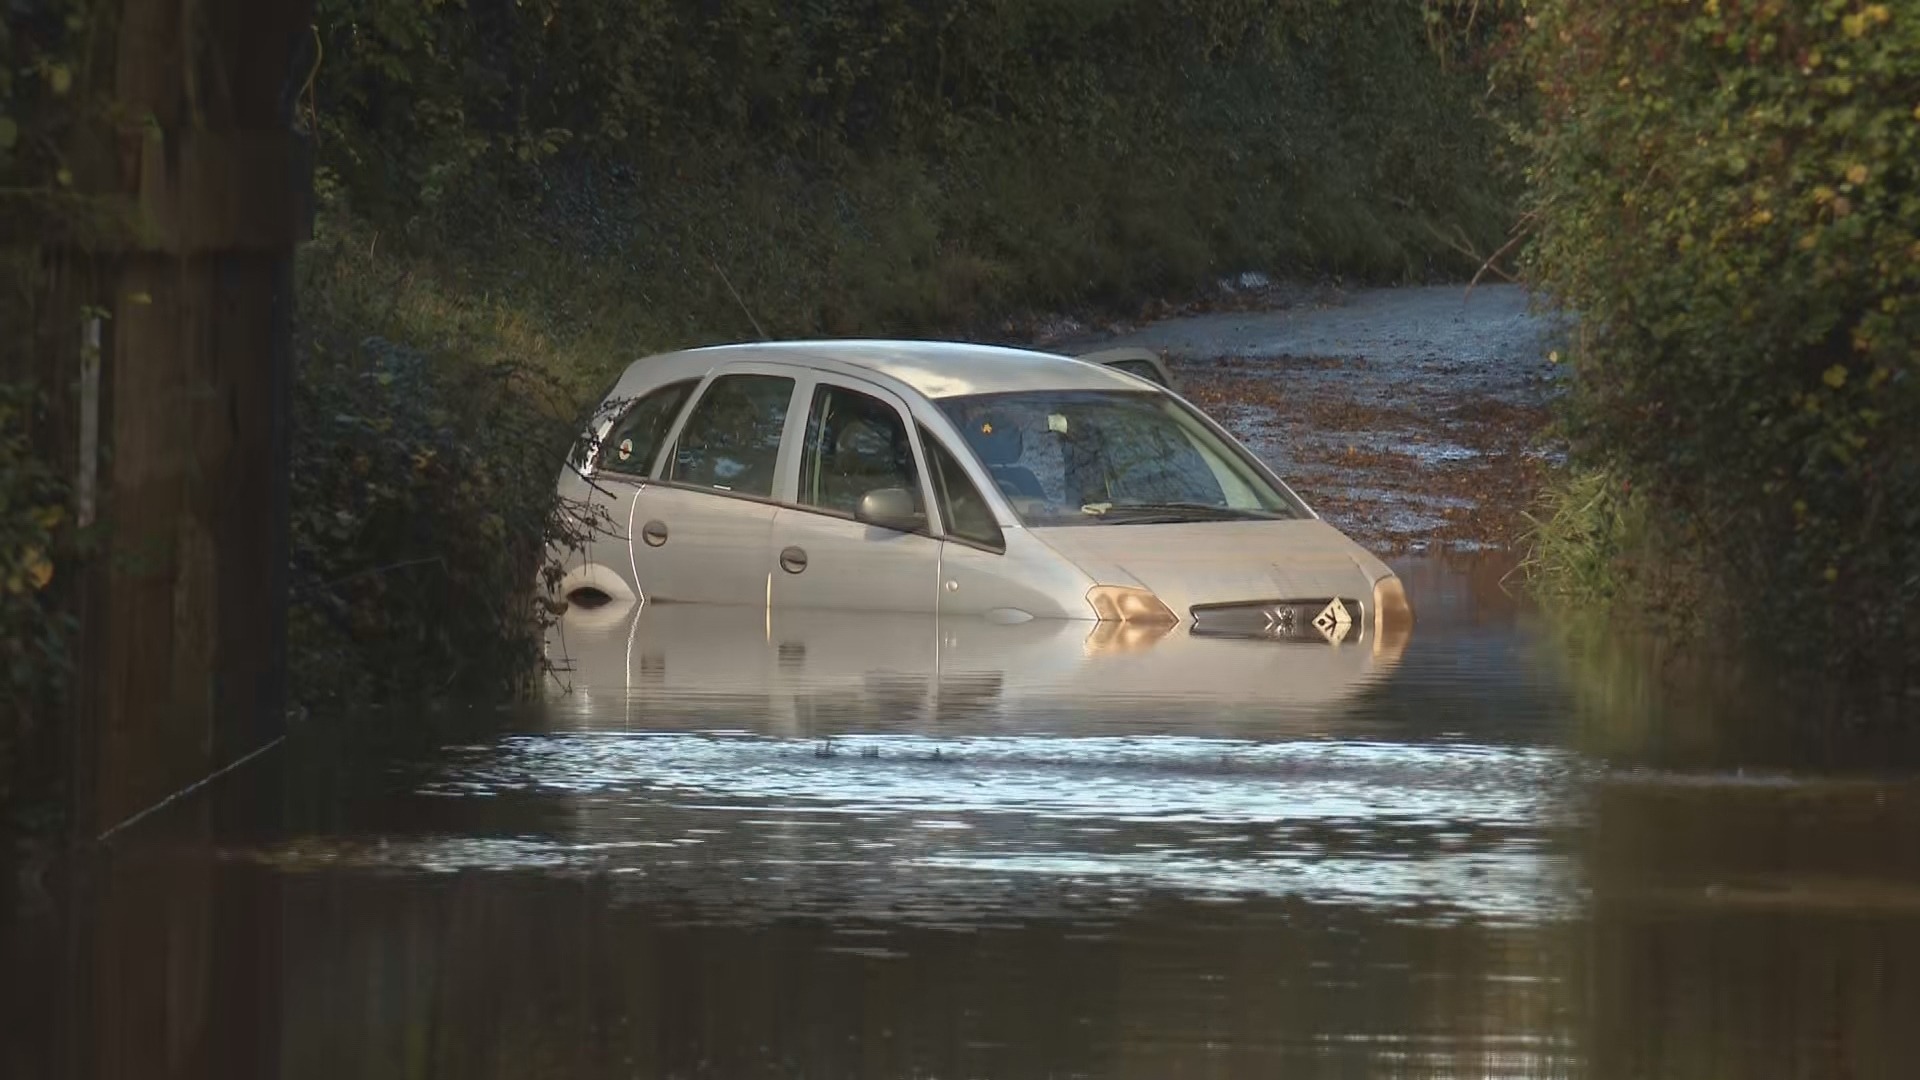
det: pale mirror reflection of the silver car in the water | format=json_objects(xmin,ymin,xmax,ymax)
[{"xmin": 547, "ymin": 588, "xmax": 1411, "ymax": 738}]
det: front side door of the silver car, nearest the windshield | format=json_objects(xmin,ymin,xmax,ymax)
[{"xmin": 768, "ymin": 375, "xmax": 941, "ymax": 613}]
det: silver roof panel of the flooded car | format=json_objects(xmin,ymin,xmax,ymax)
[{"xmin": 636, "ymin": 338, "xmax": 1140, "ymax": 398}]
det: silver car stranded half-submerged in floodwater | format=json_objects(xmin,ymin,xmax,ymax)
[{"xmin": 559, "ymin": 340, "xmax": 1411, "ymax": 642}]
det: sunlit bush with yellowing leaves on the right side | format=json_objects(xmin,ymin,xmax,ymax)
[{"xmin": 1519, "ymin": 0, "xmax": 1920, "ymax": 682}]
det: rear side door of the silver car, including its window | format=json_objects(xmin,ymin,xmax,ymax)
[{"xmin": 632, "ymin": 365, "xmax": 799, "ymax": 603}]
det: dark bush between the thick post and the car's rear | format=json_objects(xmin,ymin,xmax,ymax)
[{"xmin": 290, "ymin": 226, "xmax": 591, "ymax": 705}]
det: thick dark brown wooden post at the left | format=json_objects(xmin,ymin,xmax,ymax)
[{"xmin": 71, "ymin": 0, "xmax": 313, "ymax": 840}]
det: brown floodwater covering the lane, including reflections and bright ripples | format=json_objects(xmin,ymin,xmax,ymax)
[{"xmin": 0, "ymin": 555, "xmax": 1920, "ymax": 1080}]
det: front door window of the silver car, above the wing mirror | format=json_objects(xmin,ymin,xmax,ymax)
[{"xmin": 799, "ymin": 384, "xmax": 925, "ymax": 517}]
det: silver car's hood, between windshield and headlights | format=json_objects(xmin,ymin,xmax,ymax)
[{"xmin": 1033, "ymin": 519, "xmax": 1392, "ymax": 619}]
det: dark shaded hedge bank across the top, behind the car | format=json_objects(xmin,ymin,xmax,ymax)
[{"xmin": 311, "ymin": 0, "xmax": 1509, "ymax": 303}]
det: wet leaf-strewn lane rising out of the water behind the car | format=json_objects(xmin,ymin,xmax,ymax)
[{"xmin": 1037, "ymin": 284, "xmax": 1559, "ymax": 552}]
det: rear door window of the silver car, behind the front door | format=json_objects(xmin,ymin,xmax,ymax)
[{"xmin": 666, "ymin": 375, "xmax": 793, "ymax": 498}]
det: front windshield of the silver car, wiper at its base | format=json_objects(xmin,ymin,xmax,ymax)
[{"xmin": 937, "ymin": 390, "xmax": 1302, "ymax": 527}]
